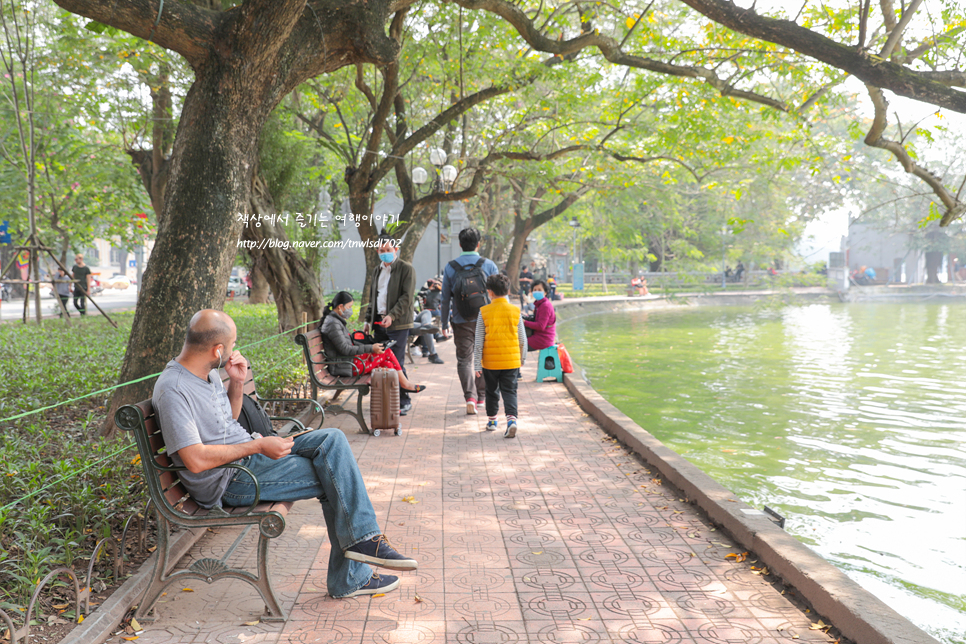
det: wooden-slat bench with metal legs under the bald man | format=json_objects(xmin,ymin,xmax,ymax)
[{"xmin": 114, "ymin": 366, "xmax": 321, "ymax": 622}]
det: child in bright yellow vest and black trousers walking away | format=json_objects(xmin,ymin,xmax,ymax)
[{"xmin": 473, "ymin": 274, "xmax": 527, "ymax": 438}]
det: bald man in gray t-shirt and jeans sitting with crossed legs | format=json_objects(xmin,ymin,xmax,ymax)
[{"xmin": 152, "ymin": 309, "xmax": 417, "ymax": 597}]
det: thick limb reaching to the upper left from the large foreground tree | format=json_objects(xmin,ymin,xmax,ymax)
[{"xmin": 54, "ymin": 0, "xmax": 222, "ymax": 69}]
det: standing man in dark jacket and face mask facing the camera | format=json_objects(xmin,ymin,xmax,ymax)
[{"xmin": 364, "ymin": 233, "xmax": 416, "ymax": 416}]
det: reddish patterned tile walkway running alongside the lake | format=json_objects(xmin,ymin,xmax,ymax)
[{"xmin": 113, "ymin": 343, "xmax": 840, "ymax": 644}]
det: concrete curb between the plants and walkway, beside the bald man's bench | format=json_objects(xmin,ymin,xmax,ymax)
[{"xmin": 60, "ymin": 528, "xmax": 207, "ymax": 644}]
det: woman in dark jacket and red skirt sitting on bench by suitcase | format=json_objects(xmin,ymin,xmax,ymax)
[{"xmin": 319, "ymin": 291, "xmax": 426, "ymax": 393}]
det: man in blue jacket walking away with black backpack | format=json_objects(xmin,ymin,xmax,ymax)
[{"xmin": 442, "ymin": 228, "xmax": 500, "ymax": 415}]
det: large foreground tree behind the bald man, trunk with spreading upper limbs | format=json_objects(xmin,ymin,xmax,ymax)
[{"xmin": 57, "ymin": 0, "xmax": 402, "ymax": 434}]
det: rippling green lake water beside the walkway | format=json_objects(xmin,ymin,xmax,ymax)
[{"xmin": 557, "ymin": 303, "xmax": 966, "ymax": 644}]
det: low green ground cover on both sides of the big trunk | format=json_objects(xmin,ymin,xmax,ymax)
[{"xmin": 0, "ymin": 303, "xmax": 306, "ymax": 616}]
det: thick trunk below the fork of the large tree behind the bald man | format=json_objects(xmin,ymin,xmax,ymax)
[{"xmin": 100, "ymin": 64, "xmax": 274, "ymax": 436}]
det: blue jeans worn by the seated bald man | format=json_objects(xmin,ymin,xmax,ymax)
[{"xmin": 221, "ymin": 429, "xmax": 382, "ymax": 597}]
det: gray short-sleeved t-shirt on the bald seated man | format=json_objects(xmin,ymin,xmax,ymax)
[{"xmin": 151, "ymin": 360, "xmax": 252, "ymax": 508}]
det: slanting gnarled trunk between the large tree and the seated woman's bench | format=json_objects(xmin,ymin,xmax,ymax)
[{"xmin": 242, "ymin": 174, "xmax": 322, "ymax": 331}]
